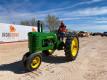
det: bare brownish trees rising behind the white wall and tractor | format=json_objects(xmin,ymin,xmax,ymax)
[{"xmin": 20, "ymin": 15, "xmax": 60, "ymax": 32}]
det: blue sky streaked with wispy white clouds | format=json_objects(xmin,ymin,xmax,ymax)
[{"xmin": 0, "ymin": 0, "xmax": 107, "ymax": 32}]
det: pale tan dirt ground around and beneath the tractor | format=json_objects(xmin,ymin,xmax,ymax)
[{"xmin": 0, "ymin": 36, "xmax": 107, "ymax": 80}]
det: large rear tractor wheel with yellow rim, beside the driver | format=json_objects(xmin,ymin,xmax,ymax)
[{"xmin": 65, "ymin": 36, "xmax": 79, "ymax": 61}]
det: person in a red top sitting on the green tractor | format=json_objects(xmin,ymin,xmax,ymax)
[{"xmin": 58, "ymin": 21, "xmax": 67, "ymax": 41}]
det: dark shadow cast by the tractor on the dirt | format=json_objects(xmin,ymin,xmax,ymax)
[{"xmin": 0, "ymin": 56, "xmax": 66, "ymax": 74}]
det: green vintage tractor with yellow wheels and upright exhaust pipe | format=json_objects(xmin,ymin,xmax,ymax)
[{"xmin": 22, "ymin": 21, "xmax": 79, "ymax": 71}]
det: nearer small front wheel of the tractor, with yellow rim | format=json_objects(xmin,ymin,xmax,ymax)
[{"xmin": 25, "ymin": 53, "xmax": 42, "ymax": 71}]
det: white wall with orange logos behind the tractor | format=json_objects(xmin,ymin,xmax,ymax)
[{"xmin": 0, "ymin": 23, "xmax": 37, "ymax": 43}]
